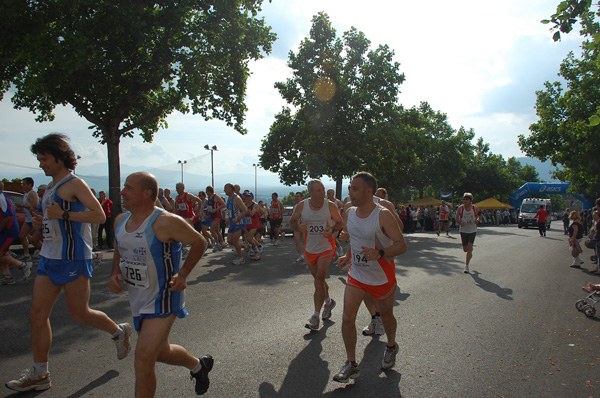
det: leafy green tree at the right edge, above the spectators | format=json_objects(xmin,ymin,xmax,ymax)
[{"xmin": 519, "ymin": 14, "xmax": 600, "ymax": 197}]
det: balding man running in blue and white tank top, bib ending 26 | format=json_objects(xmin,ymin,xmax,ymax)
[{"xmin": 108, "ymin": 172, "xmax": 213, "ymax": 397}]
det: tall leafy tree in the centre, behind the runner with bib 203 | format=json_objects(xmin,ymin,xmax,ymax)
[{"xmin": 260, "ymin": 12, "xmax": 404, "ymax": 197}]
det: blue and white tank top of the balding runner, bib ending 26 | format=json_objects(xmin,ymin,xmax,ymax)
[{"xmin": 115, "ymin": 208, "xmax": 185, "ymax": 317}]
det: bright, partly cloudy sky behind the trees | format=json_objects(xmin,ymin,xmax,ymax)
[{"xmin": 0, "ymin": 0, "xmax": 581, "ymax": 183}]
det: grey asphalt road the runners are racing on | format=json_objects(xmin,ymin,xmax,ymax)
[{"xmin": 0, "ymin": 226, "xmax": 600, "ymax": 398}]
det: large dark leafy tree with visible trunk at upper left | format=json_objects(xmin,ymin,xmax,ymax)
[{"xmin": 0, "ymin": 0, "xmax": 275, "ymax": 212}]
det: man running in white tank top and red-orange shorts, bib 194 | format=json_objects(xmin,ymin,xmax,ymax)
[{"xmin": 333, "ymin": 172, "xmax": 406, "ymax": 383}]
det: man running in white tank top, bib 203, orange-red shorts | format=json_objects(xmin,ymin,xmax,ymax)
[{"xmin": 290, "ymin": 179, "xmax": 342, "ymax": 330}]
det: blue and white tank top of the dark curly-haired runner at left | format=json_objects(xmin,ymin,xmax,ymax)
[{"xmin": 40, "ymin": 173, "xmax": 92, "ymax": 260}]
